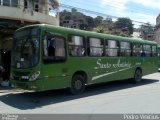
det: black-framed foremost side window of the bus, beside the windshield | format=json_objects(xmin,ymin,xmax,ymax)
[{"xmin": 44, "ymin": 35, "xmax": 66, "ymax": 63}]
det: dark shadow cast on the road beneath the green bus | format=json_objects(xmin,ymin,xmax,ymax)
[{"xmin": 0, "ymin": 79, "xmax": 159, "ymax": 110}]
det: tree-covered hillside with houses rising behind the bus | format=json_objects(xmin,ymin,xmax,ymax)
[{"xmin": 60, "ymin": 8, "xmax": 133, "ymax": 36}]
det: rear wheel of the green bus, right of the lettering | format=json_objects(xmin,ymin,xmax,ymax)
[{"xmin": 132, "ymin": 69, "xmax": 142, "ymax": 83}]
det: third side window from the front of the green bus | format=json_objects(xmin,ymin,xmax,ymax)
[{"xmin": 88, "ymin": 38, "xmax": 104, "ymax": 56}]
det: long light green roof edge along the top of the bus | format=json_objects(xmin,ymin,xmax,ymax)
[{"xmin": 17, "ymin": 24, "xmax": 157, "ymax": 44}]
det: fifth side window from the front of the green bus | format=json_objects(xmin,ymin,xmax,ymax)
[{"xmin": 120, "ymin": 42, "xmax": 131, "ymax": 57}]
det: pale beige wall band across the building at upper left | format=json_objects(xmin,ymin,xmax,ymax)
[{"xmin": 0, "ymin": 6, "xmax": 59, "ymax": 25}]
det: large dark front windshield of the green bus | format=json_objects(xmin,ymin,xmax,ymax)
[{"xmin": 12, "ymin": 27, "xmax": 40, "ymax": 69}]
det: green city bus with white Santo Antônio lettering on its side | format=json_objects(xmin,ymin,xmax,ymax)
[{"xmin": 11, "ymin": 24, "xmax": 158, "ymax": 94}]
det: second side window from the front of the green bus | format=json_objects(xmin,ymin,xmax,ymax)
[{"xmin": 68, "ymin": 36, "xmax": 86, "ymax": 56}]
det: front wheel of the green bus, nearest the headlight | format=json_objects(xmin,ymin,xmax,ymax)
[{"xmin": 70, "ymin": 74, "xmax": 85, "ymax": 95}]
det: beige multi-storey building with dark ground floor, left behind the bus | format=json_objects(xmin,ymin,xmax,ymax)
[{"xmin": 0, "ymin": 0, "xmax": 59, "ymax": 81}]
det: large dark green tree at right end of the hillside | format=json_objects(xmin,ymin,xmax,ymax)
[{"xmin": 114, "ymin": 18, "xmax": 133, "ymax": 35}]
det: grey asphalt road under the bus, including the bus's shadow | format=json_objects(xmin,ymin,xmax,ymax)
[{"xmin": 0, "ymin": 73, "xmax": 160, "ymax": 114}]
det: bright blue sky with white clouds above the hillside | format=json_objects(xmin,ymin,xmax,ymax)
[{"xmin": 59, "ymin": 0, "xmax": 160, "ymax": 25}]
